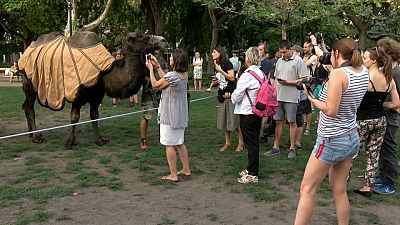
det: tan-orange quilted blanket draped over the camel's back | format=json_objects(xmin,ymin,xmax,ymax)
[{"xmin": 18, "ymin": 35, "xmax": 114, "ymax": 110}]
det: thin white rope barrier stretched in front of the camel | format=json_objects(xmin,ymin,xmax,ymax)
[{"xmin": 0, "ymin": 96, "xmax": 215, "ymax": 140}]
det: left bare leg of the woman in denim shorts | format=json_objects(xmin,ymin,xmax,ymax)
[{"xmin": 294, "ymin": 155, "xmax": 330, "ymax": 225}]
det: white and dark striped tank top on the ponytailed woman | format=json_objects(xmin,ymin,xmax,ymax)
[{"xmin": 317, "ymin": 67, "xmax": 368, "ymax": 137}]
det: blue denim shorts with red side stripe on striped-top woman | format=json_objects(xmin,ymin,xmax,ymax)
[{"xmin": 312, "ymin": 131, "xmax": 360, "ymax": 165}]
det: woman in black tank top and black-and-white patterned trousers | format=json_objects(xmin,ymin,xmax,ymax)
[{"xmin": 354, "ymin": 47, "xmax": 400, "ymax": 197}]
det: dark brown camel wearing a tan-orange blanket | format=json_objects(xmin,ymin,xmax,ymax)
[{"xmin": 19, "ymin": 31, "xmax": 168, "ymax": 149}]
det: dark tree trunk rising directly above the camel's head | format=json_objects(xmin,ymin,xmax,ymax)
[{"xmin": 143, "ymin": 0, "xmax": 165, "ymax": 36}]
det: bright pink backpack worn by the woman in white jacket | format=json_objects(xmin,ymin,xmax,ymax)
[{"xmin": 246, "ymin": 70, "xmax": 278, "ymax": 117}]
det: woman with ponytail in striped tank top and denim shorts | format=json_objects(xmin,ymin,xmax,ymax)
[{"xmin": 294, "ymin": 38, "xmax": 368, "ymax": 225}]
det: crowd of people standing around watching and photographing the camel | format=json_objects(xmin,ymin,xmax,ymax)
[{"xmin": 117, "ymin": 35, "xmax": 400, "ymax": 224}]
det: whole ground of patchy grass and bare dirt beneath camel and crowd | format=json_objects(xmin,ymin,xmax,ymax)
[{"xmin": 0, "ymin": 78, "xmax": 400, "ymax": 225}]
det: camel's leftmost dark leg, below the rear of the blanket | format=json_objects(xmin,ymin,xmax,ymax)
[{"xmin": 22, "ymin": 74, "xmax": 44, "ymax": 143}]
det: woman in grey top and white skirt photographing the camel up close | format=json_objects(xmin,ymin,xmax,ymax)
[{"xmin": 146, "ymin": 49, "xmax": 191, "ymax": 182}]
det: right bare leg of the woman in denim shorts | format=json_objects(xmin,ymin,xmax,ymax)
[{"xmin": 329, "ymin": 159, "xmax": 352, "ymax": 225}]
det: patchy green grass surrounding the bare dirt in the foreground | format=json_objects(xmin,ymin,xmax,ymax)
[{"xmin": 0, "ymin": 88, "xmax": 400, "ymax": 224}]
